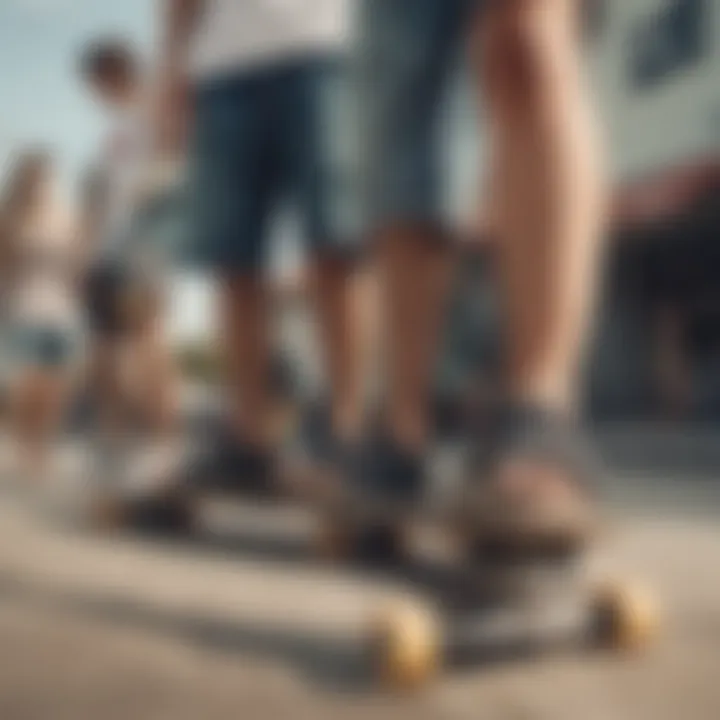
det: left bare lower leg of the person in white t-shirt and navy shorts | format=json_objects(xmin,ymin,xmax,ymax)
[{"xmin": 220, "ymin": 276, "xmax": 272, "ymax": 448}]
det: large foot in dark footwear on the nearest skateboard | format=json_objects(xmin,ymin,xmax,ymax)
[{"xmin": 463, "ymin": 406, "xmax": 599, "ymax": 554}]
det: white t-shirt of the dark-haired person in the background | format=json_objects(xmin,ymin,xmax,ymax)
[{"xmin": 97, "ymin": 104, "xmax": 150, "ymax": 256}]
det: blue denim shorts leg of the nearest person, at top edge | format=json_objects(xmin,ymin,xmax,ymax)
[{"xmin": 358, "ymin": 0, "xmax": 481, "ymax": 230}]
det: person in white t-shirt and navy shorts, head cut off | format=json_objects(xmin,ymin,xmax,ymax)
[{"xmin": 156, "ymin": 0, "xmax": 363, "ymax": 492}]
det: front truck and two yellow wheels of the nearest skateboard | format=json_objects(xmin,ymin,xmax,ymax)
[{"xmin": 365, "ymin": 561, "xmax": 660, "ymax": 690}]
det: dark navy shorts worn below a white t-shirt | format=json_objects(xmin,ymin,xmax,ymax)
[{"xmin": 188, "ymin": 56, "xmax": 358, "ymax": 273}]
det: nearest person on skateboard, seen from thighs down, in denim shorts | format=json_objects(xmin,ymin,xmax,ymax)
[{"xmin": 359, "ymin": 0, "xmax": 605, "ymax": 543}]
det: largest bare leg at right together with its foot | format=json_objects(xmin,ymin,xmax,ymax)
[{"xmin": 458, "ymin": 0, "xmax": 605, "ymax": 536}]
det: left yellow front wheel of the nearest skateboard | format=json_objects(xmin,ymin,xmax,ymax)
[{"xmin": 369, "ymin": 603, "xmax": 441, "ymax": 690}]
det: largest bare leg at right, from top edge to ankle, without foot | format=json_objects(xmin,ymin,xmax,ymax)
[{"xmin": 483, "ymin": 0, "xmax": 604, "ymax": 412}]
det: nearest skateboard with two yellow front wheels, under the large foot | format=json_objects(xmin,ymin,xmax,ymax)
[{"xmin": 312, "ymin": 442, "xmax": 660, "ymax": 690}]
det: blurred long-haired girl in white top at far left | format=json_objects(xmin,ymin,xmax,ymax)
[{"xmin": 0, "ymin": 151, "xmax": 80, "ymax": 474}]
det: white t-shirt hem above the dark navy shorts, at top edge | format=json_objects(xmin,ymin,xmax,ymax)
[{"xmin": 190, "ymin": 0, "xmax": 350, "ymax": 80}]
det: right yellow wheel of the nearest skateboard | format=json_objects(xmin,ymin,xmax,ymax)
[{"xmin": 594, "ymin": 583, "xmax": 660, "ymax": 651}]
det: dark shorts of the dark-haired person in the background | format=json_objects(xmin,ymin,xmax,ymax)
[{"xmin": 85, "ymin": 262, "xmax": 160, "ymax": 339}]
